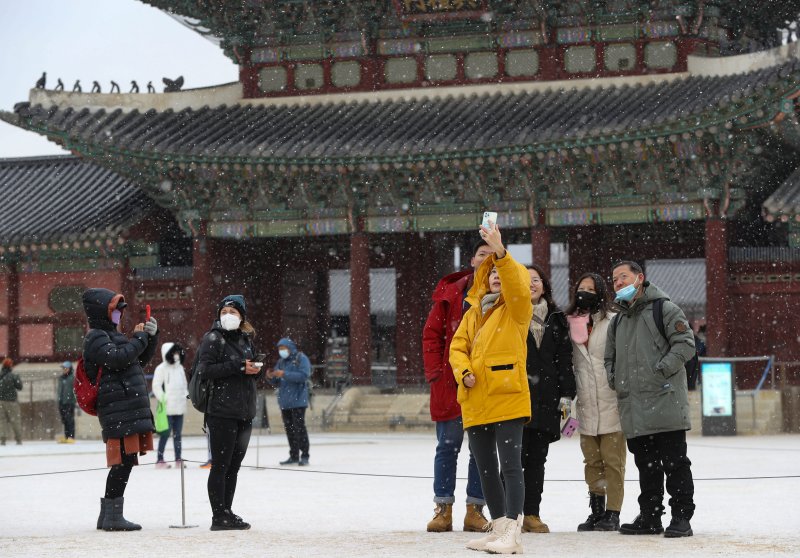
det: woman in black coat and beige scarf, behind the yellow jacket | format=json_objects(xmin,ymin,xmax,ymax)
[{"xmin": 522, "ymin": 265, "xmax": 575, "ymax": 533}]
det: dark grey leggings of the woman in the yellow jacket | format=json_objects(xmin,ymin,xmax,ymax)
[{"xmin": 467, "ymin": 418, "xmax": 525, "ymax": 519}]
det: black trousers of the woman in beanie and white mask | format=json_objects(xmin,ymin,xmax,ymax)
[{"xmin": 206, "ymin": 415, "xmax": 253, "ymax": 516}]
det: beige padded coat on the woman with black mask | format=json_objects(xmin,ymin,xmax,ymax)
[{"xmin": 572, "ymin": 313, "xmax": 622, "ymax": 436}]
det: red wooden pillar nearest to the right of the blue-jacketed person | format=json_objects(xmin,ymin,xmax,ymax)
[{"xmin": 350, "ymin": 231, "xmax": 372, "ymax": 384}]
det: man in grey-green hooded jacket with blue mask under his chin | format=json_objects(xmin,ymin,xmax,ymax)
[{"xmin": 605, "ymin": 261, "xmax": 695, "ymax": 537}]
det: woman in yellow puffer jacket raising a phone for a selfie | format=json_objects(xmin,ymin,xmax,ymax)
[{"xmin": 450, "ymin": 223, "xmax": 533, "ymax": 554}]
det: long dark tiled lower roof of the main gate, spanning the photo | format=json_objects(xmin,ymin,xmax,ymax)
[{"xmin": 3, "ymin": 61, "xmax": 800, "ymax": 164}]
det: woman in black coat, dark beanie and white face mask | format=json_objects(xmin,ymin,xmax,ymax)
[{"xmin": 196, "ymin": 295, "xmax": 263, "ymax": 531}]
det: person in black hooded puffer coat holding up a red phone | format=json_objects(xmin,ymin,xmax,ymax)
[{"xmin": 83, "ymin": 289, "xmax": 158, "ymax": 531}]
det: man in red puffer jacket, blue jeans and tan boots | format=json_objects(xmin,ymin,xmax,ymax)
[{"xmin": 422, "ymin": 240, "xmax": 492, "ymax": 533}]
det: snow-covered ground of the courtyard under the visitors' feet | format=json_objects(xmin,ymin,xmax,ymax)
[{"xmin": 0, "ymin": 432, "xmax": 800, "ymax": 558}]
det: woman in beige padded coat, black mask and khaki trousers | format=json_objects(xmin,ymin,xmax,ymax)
[{"xmin": 566, "ymin": 273, "xmax": 627, "ymax": 531}]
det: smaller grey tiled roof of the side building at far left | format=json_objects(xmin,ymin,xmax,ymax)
[{"xmin": 0, "ymin": 156, "xmax": 152, "ymax": 245}]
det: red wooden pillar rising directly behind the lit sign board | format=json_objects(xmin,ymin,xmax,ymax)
[{"xmin": 706, "ymin": 217, "xmax": 728, "ymax": 357}]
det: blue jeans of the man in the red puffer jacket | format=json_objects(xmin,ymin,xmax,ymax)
[{"xmin": 433, "ymin": 417, "xmax": 485, "ymax": 506}]
